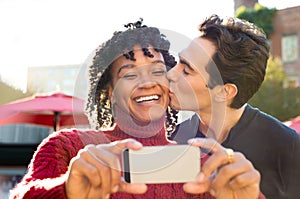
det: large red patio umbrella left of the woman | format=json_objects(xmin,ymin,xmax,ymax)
[{"xmin": 0, "ymin": 93, "xmax": 89, "ymax": 131}]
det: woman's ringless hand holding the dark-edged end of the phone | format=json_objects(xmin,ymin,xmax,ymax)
[{"xmin": 65, "ymin": 139, "xmax": 147, "ymax": 199}]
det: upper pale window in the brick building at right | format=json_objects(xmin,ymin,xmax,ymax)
[{"xmin": 281, "ymin": 34, "xmax": 298, "ymax": 62}]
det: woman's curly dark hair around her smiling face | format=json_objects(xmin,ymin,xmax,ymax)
[{"xmin": 85, "ymin": 19, "xmax": 177, "ymax": 135}]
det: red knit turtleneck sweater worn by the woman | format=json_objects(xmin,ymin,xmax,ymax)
[{"xmin": 10, "ymin": 112, "xmax": 264, "ymax": 199}]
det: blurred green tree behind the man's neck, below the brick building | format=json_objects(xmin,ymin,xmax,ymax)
[{"xmin": 249, "ymin": 57, "xmax": 300, "ymax": 121}]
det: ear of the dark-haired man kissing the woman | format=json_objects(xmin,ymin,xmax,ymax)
[{"xmin": 213, "ymin": 84, "xmax": 238, "ymax": 102}]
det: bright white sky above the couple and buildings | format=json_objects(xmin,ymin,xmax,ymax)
[{"xmin": 0, "ymin": 0, "xmax": 300, "ymax": 91}]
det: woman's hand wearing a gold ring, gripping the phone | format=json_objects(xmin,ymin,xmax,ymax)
[{"xmin": 184, "ymin": 138, "xmax": 260, "ymax": 199}]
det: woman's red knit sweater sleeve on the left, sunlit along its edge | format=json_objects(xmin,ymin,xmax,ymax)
[{"xmin": 10, "ymin": 128, "xmax": 83, "ymax": 199}]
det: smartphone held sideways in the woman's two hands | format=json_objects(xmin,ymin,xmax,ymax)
[{"xmin": 122, "ymin": 145, "xmax": 201, "ymax": 184}]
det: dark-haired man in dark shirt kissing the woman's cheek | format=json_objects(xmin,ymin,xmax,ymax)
[{"xmin": 168, "ymin": 15, "xmax": 300, "ymax": 198}]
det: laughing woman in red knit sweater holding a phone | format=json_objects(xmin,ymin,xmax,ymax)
[{"xmin": 10, "ymin": 21, "xmax": 260, "ymax": 199}]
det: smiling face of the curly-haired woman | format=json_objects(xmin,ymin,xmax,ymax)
[{"xmin": 111, "ymin": 46, "xmax": 169, "ymax": 122}]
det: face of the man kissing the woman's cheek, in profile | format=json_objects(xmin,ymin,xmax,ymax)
[{"xmin": 167, "ymin": 38, "xmax": 215, "ymax": 112}]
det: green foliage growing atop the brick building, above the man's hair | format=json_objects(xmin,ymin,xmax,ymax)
[{"xmin": 235, "ymin": 3, "xmax": 276, "ymax": 37}]
